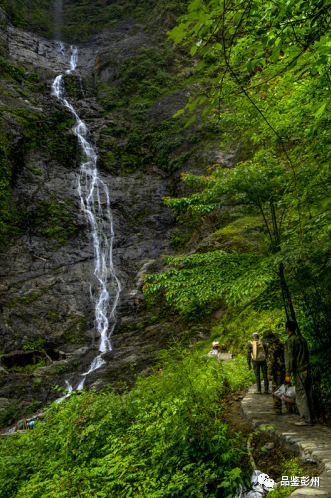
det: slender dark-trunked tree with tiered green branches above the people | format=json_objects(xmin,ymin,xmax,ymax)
[{"xmin": 148, "ymin": 145, "xmax": 331, "ymax": 411}]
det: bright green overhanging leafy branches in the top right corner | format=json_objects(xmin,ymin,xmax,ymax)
[{"xmin": 170, "ymin": 0, "xmax": 330, "ymax": 130}]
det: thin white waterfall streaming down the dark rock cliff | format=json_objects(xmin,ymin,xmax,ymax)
[{"xmin": 52, "ymin": 43, "xmax": 121, "ymax": 392}]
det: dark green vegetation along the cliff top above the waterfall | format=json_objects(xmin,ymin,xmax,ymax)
[{"xmin": 0, "ymin": 0, "xmax": 185, "ymax": 42}]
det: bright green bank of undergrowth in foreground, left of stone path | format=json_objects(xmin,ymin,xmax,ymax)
[{"xmin": 0, "ymin": 346, "xmax": 252, "ymax": 498}]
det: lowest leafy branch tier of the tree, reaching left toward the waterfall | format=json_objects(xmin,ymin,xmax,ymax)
[{"xmin": 144, "ymin": 251, "xmax": 264, "ymax": 316}]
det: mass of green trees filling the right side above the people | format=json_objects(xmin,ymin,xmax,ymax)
[{"xmin": 145, "ymin": 0, "xmax": 331, "ymax": 418}]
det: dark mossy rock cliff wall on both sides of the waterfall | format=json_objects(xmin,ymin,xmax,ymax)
[{"xmin": 0, "ymin": 1, "xmax": 234, "ymax": 422}]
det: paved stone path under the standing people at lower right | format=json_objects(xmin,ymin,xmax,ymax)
[{"xmin": 241, "ymin": 385, "xmax": 331, "ymax": 498}]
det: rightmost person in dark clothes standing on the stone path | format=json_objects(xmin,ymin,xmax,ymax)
[{"xmin": 285, "ymin": 321, "xmax": 313, "ymax": 425}]
